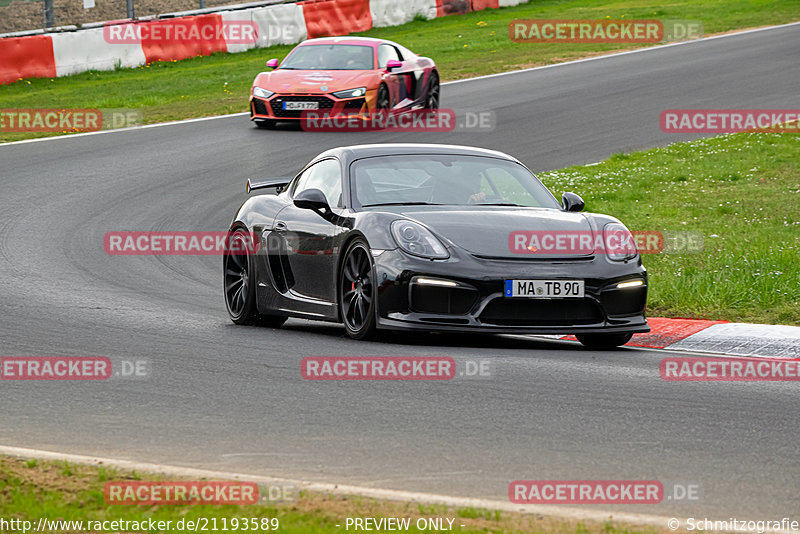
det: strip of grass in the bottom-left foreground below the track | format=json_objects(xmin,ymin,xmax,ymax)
[{"xmin": 0, "ymin": 457, "xmax": 668, "ymax": 534}]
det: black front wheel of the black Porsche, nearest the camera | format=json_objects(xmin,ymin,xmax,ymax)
[{"xmin": 338, "ymin": 238, "xmax": 377, "ymax": 339}]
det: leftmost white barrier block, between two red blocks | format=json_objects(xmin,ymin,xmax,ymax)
[{"xmin": 52, "ymin": 28, "xmax": 146, "ymax": 76}]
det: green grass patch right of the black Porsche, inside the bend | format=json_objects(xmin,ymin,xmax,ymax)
[{"xmin": 539, "ymin": 133, "xmax": 800, "ymax": 325}]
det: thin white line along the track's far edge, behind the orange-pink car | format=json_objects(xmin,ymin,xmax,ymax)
[{"xmin": 0, "ymin": 22, "xmax": 800, "ymax": 147}]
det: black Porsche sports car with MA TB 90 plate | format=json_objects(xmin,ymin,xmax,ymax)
[{"xmin": 223, "ymin": 144, "xmax": 650, "ymax": 348}]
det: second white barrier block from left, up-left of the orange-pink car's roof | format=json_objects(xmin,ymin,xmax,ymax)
[{"xmin": 220, "ymin": 4, "xmax": 307, "ymax": 52}]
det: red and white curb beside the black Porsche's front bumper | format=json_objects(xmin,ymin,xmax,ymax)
[{"xmin": 559, "ymin": 317, "xmax": 800, "ymax": 358}]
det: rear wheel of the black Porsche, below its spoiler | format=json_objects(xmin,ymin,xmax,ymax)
[{"xmin": 222, "ymin": 229, "xmax": 286, "ymax": 328}]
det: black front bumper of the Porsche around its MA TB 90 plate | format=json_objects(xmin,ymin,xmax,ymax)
[{"xmin": 374, "ymin": 250, "xmax": 650, "ymax": 334}]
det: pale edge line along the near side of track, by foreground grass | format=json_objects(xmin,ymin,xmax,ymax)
[{"xmin": 0, "ymin": 445, "xmax": 680, "ymax": 534}]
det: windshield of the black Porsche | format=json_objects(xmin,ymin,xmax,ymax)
[{"xmin": 351, "ymin": 155, "xmax": 560, "ymax": 209}]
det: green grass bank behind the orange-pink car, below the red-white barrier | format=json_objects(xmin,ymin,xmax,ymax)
[{"xmin": 0, "ymin": 0, "xmax": 800, "ymax": 141}]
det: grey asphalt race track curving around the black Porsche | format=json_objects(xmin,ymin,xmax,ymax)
[{"xmin": 0, "ymin": 25, "xmax": 800, "ymax": 519}]
